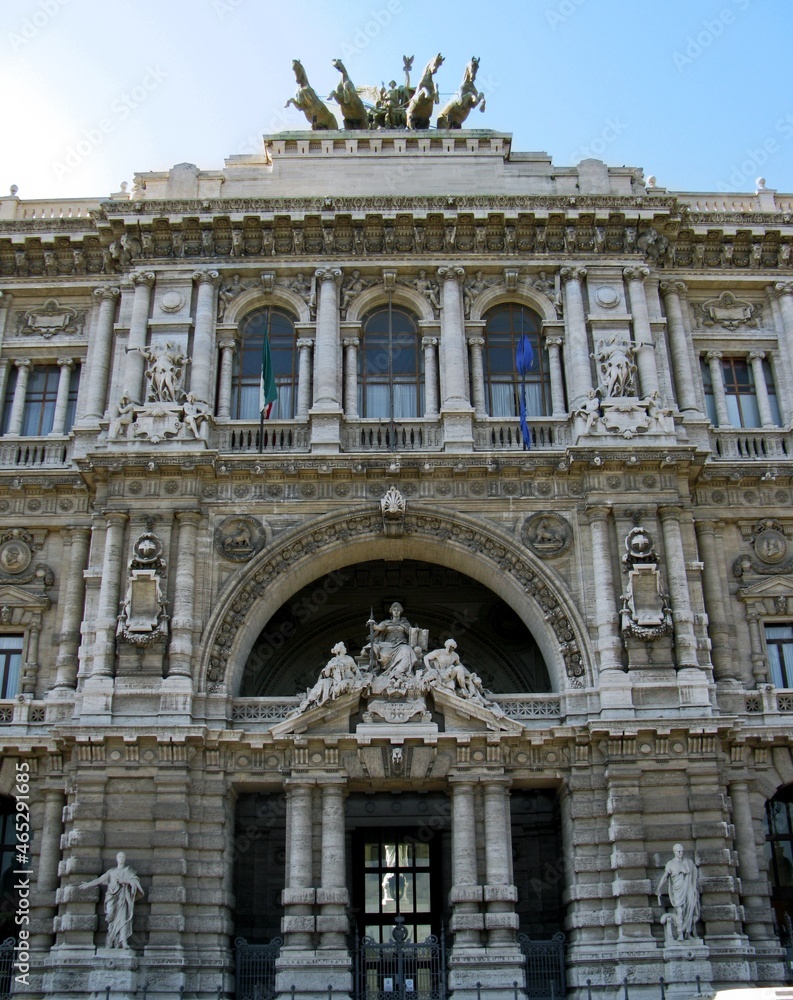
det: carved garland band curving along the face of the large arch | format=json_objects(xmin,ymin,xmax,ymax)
[{"xmin": 207, "ymin": 510, "xmax": 584, "ymax": 690}]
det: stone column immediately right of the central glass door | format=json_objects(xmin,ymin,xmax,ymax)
[{"xmin": 449, "ymin": 777, "xmax": 484, "ymax": 949}]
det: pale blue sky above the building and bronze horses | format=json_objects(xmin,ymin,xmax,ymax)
[{"xmin": 0, "ymin": 0, "xmax": 793, "ymax": 198}]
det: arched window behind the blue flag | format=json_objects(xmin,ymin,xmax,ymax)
[{"xmin": 484, "ymin": 302, "xmax": 551, "ymax": 417}]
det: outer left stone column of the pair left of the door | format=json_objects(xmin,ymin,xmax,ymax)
[{"xmin": 281, "ymin": 780, "xmax": 316, "ymax": 950}]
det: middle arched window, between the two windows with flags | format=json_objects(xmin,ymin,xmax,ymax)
[{"xmin": 358, "ymin": 306, "xmax": 424, "ymax": 420}]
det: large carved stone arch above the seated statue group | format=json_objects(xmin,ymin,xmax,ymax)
[{"xmin": 199, "ymin": 503, "xmax": 593, "ymax": 693}]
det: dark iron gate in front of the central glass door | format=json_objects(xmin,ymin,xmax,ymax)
[{"xmin": 355, "ymin": 916, "xmax": 446, "ymax": 1000}]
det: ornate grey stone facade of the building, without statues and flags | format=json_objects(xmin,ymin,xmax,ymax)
[{"xmin": 0, "ymin": 130, "xmax": 793, "ymax": 998}]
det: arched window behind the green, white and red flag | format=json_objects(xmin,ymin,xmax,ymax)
[{"xmin": 231, "ymin": 306, "xmax": 298, "ymax": 420}]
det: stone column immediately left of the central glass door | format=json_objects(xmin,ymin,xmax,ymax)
[{"xmin": 317, "ymin": 779, "xmax": 350, "ymax": 950}]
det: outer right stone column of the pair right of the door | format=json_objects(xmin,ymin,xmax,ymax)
[{"xmin": 484, "ymin": 778, "xmax": 518, "ymax": 948}]
